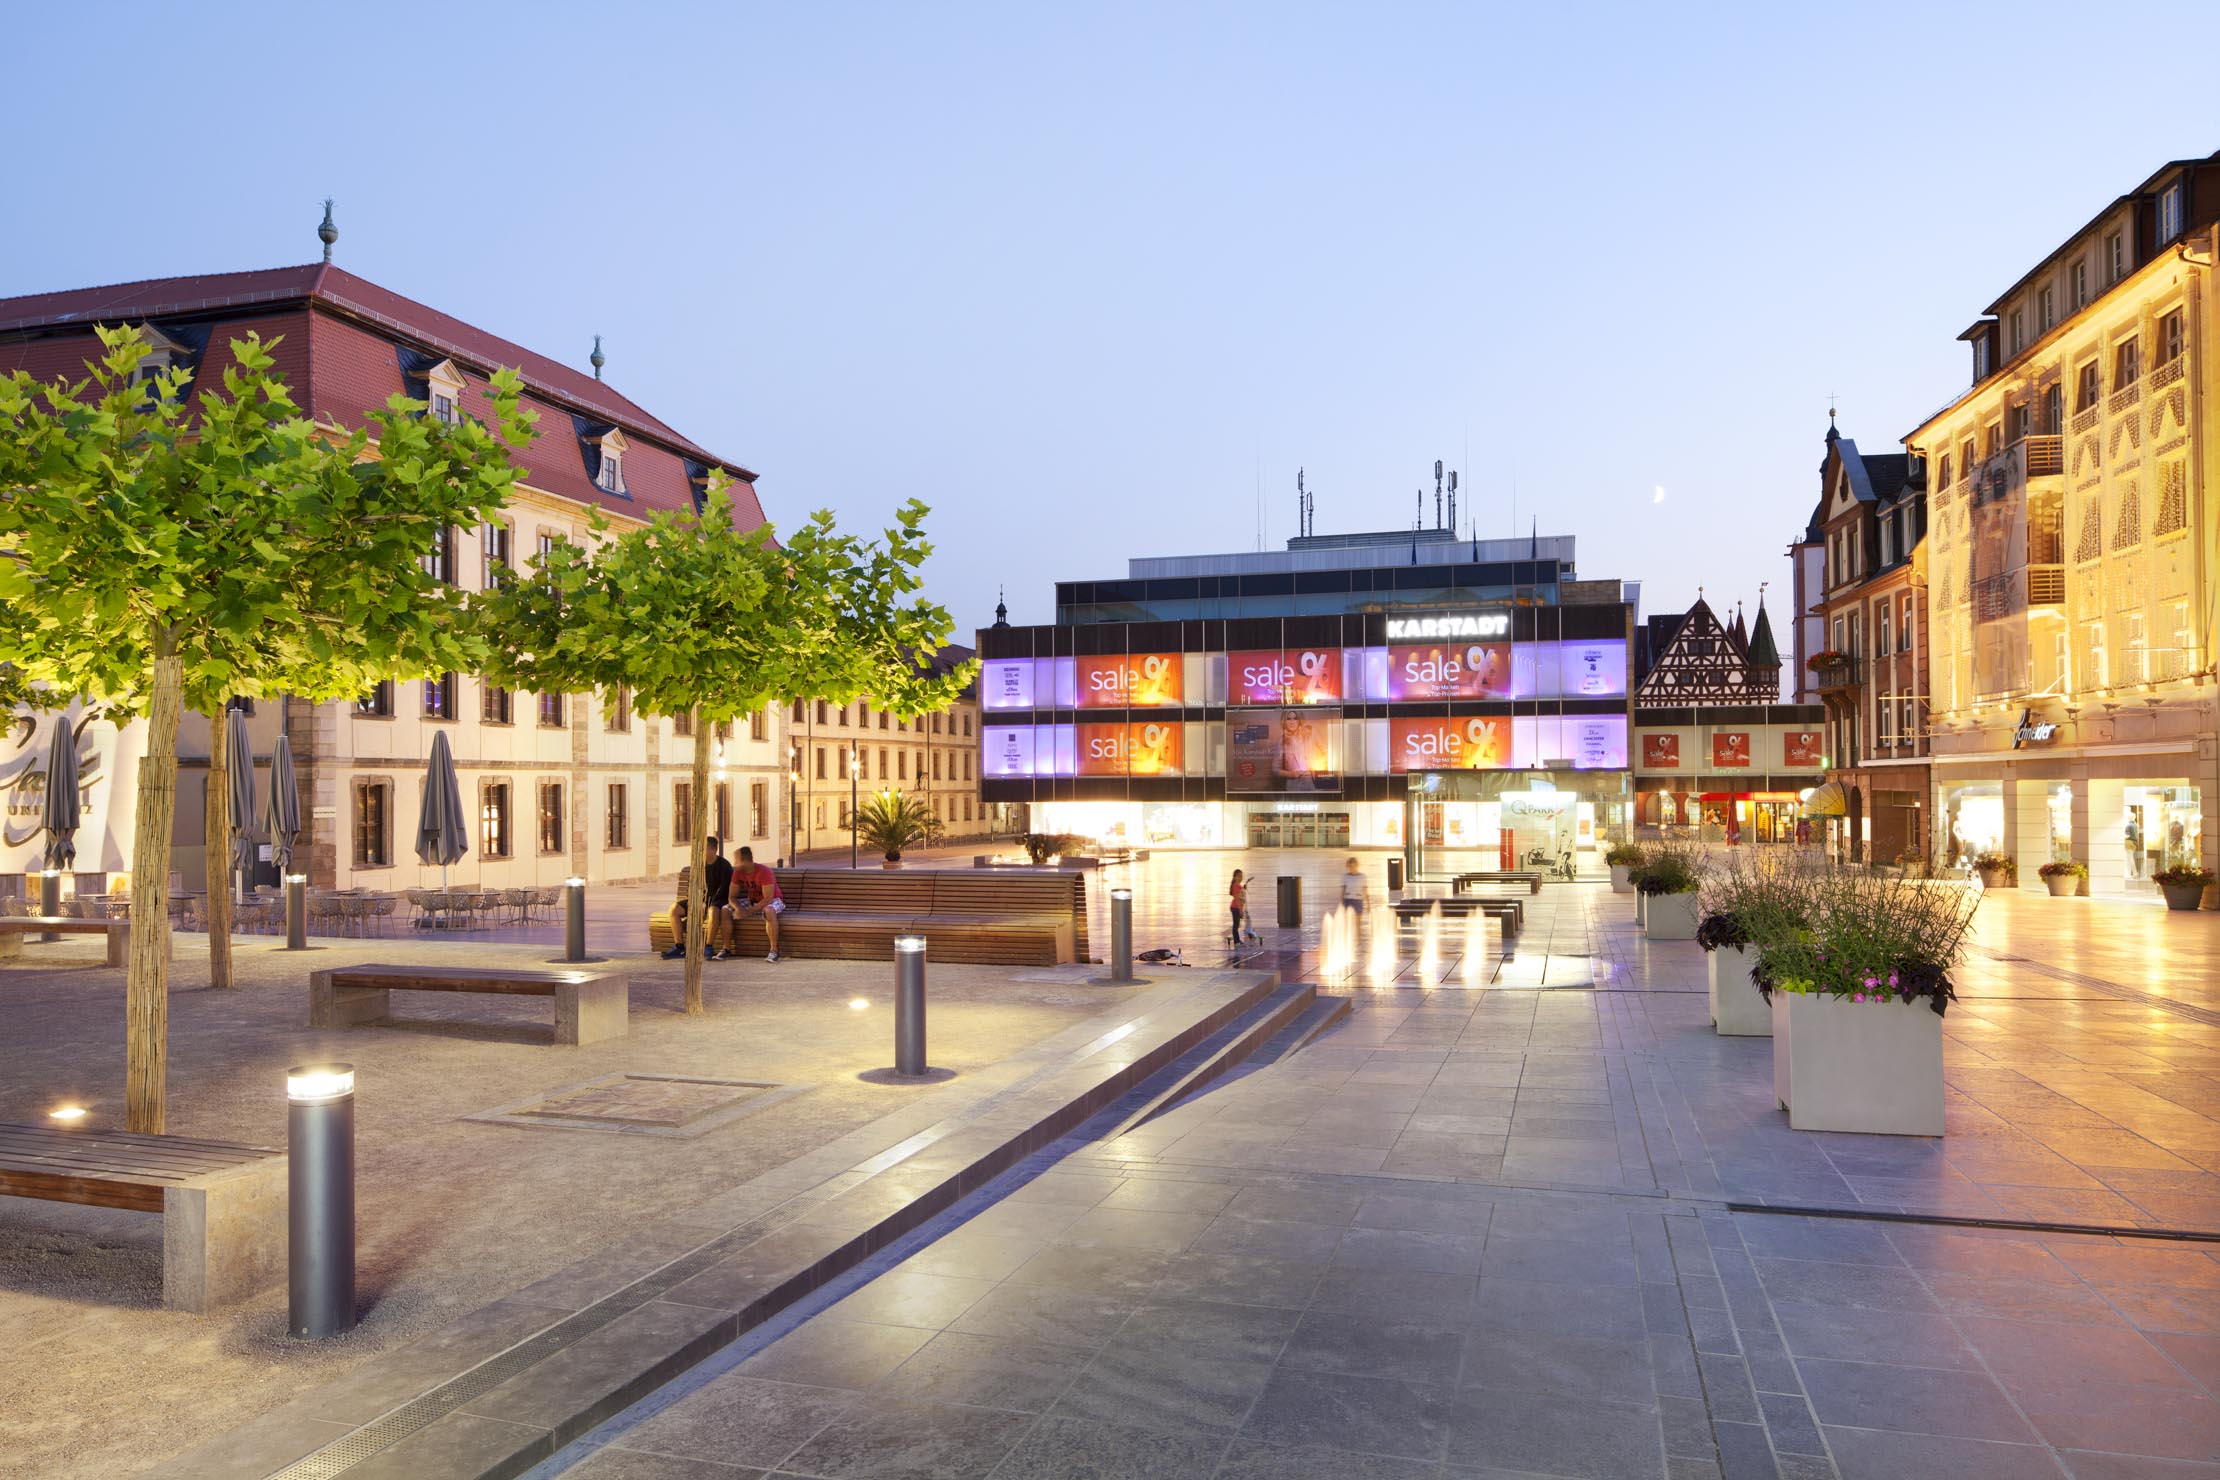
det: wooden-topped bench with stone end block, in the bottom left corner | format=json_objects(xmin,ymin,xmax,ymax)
[{"xmin": 0, "ymin": 1125, "xmax": 286, "ymax": 1311}]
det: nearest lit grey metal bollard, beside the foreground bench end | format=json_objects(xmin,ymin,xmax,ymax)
[{"xmin": 284, "ymin": 1063, "xmax": 355, "ymax": 1340}]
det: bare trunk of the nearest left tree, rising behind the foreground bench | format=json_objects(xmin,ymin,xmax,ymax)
[{"xmin": 124, "ymin": 637, "xmax": 184, "ymax": 1136}]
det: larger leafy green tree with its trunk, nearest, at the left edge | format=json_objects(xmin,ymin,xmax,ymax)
[{"xmin": 0, "ymin": 328, "xmax": 533, "ymax": 1132}]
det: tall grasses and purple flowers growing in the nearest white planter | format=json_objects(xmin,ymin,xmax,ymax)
[{"xmin": 1752, "ymin": 870, "xmax": 1980, "ymax": 1016}]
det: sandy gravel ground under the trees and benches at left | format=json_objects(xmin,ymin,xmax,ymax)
[{"xmin": 0, "ymin": 936, "xmax": 1145, "ymax": 1480}]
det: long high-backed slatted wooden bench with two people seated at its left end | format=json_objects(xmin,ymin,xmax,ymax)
[{"xmin": 648, "ymin": 868, "xmax": 1090, "ymax": 965}]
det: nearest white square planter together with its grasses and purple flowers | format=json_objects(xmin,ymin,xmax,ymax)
[{"xmin": 1754, "ymin": 870, "xmax": 1980, "ymax": 1136}]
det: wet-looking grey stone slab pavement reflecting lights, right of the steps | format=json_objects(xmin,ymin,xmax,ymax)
[{"xmin": 539, "ymin": 888, "xmax": 2220, "ymax": 1480}]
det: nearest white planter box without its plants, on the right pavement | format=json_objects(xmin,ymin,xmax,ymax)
[{"xmin": 1774, "ymin": 992, "xmax": 1943, "ymax": 1136}]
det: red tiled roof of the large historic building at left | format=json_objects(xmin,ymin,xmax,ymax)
[{"xmin": 0, "ymin": 264, "xmax": 764, "ymax": 528}]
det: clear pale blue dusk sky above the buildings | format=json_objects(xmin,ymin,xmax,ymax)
[{"xmin": 0, "ymin": 4, "xmax": 2220, "ymax": 635}]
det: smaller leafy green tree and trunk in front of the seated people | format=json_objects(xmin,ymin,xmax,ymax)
[{"xmin": 482, "ymin": 477, "xmax": 970, "ymax": 1012}]
